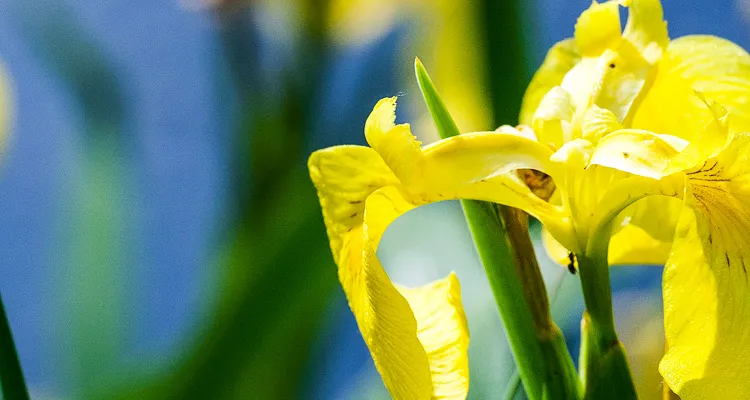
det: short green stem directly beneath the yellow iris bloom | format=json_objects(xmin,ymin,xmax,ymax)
[{"xmin": 577, "ymin": 226, "xmax": 637, "ymax": 399}]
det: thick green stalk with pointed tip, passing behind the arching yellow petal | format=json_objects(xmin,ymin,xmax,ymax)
[{"xmin": 415, "ymin": 59, "xmax": 580, "ymax": 400}]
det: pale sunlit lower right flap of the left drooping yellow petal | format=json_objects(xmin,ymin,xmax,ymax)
[{"xmin": 398, "ymin": 273, "xmax": 469, "ymax": 399}]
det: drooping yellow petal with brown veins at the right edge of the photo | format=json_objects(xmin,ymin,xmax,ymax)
[{"xmin": 659, "ymin": 134, "xmax": 750, "ymax": 400}]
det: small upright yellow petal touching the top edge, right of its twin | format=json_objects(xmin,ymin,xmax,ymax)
[{"xmin": 622, "ymin": 0, "xmax": 669, "ymax": 64}]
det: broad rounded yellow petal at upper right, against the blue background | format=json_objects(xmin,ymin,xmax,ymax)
[{"xmin": 632, "ymin": 36, "xmax": 750, "ymax": 142}]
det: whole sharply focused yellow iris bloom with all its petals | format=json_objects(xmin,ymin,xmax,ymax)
[{"xmin": 309, "ymin": 0, "xmax": 750, "ymax": 399}]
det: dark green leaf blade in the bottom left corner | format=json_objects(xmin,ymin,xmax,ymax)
[{"xmin": 0, "ymin": 297, "xmax": 29, "ymax": 400}]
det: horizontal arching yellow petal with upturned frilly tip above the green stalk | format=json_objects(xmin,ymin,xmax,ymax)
[{"xmin": 365, "ymin": 98, "xmax": 574, "ymax": 250}]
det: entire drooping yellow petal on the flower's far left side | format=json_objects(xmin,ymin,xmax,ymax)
[{"xmin": 309, "ymin": 146, "xmax": 468, "ymax": 399}]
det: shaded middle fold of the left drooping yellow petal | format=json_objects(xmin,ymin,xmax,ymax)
[{"xmin": 358, "ymin": 186, "xmax": 433, "ymax": 399}]
